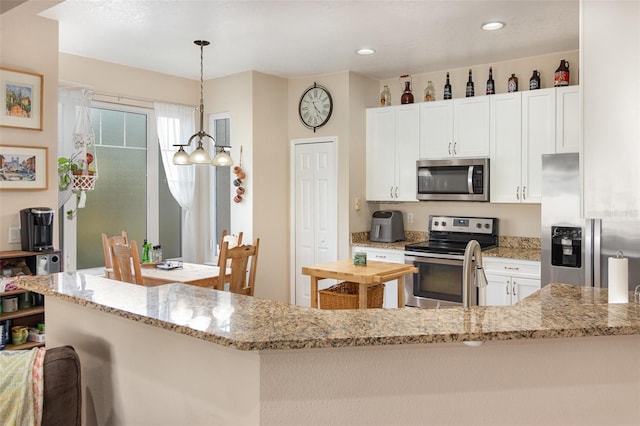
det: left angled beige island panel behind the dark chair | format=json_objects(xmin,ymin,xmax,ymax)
[{"xmin": 45, "ymin": 297, "xmax": 260, "ymax": 426}]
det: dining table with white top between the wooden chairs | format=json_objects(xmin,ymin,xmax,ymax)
[{"xmin": 140, "ymin": 263, "xmax": 231, "ymax": 288}]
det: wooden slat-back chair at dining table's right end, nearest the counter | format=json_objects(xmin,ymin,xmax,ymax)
[{"xmin": 218, "ymin": 238, "xmax": 260, "ymax": 296}]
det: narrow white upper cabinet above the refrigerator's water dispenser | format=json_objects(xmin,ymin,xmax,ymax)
[{"xmin": 556, "ymin": 86, "xmax": 580, "ymax": 153}]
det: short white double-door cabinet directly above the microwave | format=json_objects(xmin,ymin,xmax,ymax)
[{"xmin": 420, "ymin": 96, "xmax": 490, "ymax": 159}]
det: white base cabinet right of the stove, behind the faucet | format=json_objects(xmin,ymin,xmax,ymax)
[{"xmin": 481, "ymin": 257, "xmax": 540, "ymax": 306}]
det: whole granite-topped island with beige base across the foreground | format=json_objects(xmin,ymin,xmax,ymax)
[{"xmin": 19, "ymin": 273, "xmax": 640, "ymax": 424}]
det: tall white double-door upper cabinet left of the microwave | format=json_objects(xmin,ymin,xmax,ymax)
[{"xmin": 366, "ymin": 104, "xmax": 420, "ymax": 201}]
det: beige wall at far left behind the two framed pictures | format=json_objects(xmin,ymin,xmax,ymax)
[{"xmin": 0, "ymin": 2, "xmax": 58, "ymax": 250}]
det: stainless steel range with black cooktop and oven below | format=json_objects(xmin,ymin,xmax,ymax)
[{"xmin": 404, "ymin": 216, "xmax": 498, "ymax": 308}]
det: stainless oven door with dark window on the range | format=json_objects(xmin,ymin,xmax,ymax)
[{"xmin": 405, "ymin": 253, "xmax": 464, "ymax": 308}]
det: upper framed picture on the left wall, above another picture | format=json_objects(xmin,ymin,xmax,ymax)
[{"xmin": 0, "ymin": 68, "xmax": 42, "ymax": 130}]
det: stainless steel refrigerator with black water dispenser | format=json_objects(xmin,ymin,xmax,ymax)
[{"xmin": 541, "ymin": 154, "xmax": 640, "ymax": 291}]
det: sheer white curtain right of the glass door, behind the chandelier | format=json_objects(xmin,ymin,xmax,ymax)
[{"xmin": 154, "ymin": 102, "xmax": 196, "ymax": 262}]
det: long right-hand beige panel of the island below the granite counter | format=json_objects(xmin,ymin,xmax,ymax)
[{"xmin": 260, "ymin": 336, "xmax": 640, "ymax": 426}]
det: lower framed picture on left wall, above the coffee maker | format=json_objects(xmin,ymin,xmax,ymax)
[{"xmin": 0, "ymin": 145, "xmax": 48, "ymax": 190}]
